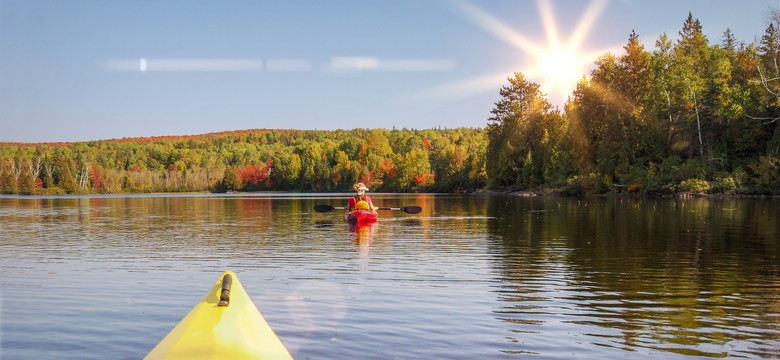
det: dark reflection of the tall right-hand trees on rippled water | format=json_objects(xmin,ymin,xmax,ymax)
[{"xmin": 488, "ymin": 196, "xmax": 780, "ymax": 356}]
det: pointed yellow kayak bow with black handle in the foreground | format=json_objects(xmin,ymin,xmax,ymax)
[{"xmin": 145, "ymin": 271, "xmax": 292, "ymax": 359}]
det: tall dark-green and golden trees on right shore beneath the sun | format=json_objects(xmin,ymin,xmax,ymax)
[{"xmin": 486, "ymin": 9, "xmax": 780, "ymax": 194}]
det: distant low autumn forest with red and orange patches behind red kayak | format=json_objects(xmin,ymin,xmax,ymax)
[{"xmin": 0, "ymin": 128, "xmax": 487, "ymax": 195}]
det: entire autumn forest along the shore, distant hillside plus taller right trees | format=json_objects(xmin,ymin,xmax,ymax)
[{"xmin": 0, "ymin": 8, "xmax": 780, "ymax": 195}]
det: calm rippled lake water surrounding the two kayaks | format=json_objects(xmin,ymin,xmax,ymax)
[{"xmin": 0, "ymin": 194, "xmax": 780, "ymax": 359}]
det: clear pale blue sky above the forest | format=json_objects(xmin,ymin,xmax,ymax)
[{"xmin": 0, "ymin": 0, "xmax": 779, "ymax": 142}]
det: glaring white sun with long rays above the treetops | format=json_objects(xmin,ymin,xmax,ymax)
[{"xmin": 426, "ymin": 0, "xmax": 607, "ymax": 105}]
